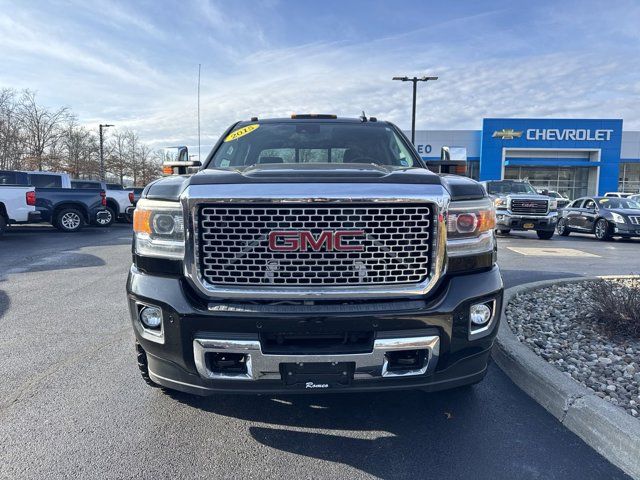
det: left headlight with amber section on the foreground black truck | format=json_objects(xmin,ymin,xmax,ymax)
[{"xmin": 133, "ymin": 199, "xmax": 184, "ymax": 259}]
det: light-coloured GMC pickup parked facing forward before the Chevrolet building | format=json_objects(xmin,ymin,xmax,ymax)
[{"xmin": 481, "ymin": 180, "xmax": 558, "ymax": 240}]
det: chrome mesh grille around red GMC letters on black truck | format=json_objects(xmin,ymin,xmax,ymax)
[{"xmin": 195, "ymin": 203, "xmax": 435, "ymax": 286}]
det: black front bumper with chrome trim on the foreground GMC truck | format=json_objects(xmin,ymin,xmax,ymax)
[{"xmin": 127, "ymin": 267, "xmax": 502, "ymax": 395}]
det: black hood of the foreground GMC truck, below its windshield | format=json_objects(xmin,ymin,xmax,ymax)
[{"xmin": 142, "ymin": 164, "xmax": 484, "ymax": 201}]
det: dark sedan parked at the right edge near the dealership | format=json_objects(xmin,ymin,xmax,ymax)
[{"xmin": 557, "ymin": 197, "xmax": 640, "ymax": 240}]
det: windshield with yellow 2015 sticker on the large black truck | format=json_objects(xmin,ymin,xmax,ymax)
[{"xmin": 209, "ymin": 121, "xmax": 420, "ymax": 169}]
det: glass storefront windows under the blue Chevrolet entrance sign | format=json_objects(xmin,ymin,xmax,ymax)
[{"xmin": 504, "ymin": 166, "xmax": 589, "ymax": 199}]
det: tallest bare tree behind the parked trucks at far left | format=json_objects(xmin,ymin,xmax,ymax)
[{"xmin": 18, "ymin": 90, "xmax": 69, "ymax": 170}]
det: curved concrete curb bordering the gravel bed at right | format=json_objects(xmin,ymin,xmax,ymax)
[{"xmin": 492, "ymin": 275, "xmax": 640, "ymax": 479}]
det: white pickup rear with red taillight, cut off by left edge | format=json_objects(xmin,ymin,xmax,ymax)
[{"xmin": 0, "ymin": 170, "xmax": 40, "ymax": 235}]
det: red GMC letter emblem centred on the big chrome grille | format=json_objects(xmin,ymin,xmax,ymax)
[{"xmin": 269, "ymin": 230, "xmax": 364, "ymax": 252}]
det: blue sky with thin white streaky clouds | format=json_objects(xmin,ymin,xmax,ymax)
[{"xmin": 0, "ymin": 0, "xmax": 640, "ymax": 156}]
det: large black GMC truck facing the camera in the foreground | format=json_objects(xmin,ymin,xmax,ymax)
[{"xmin": 127, "ymin": 115, "xmax": 503, "ymax": 395}]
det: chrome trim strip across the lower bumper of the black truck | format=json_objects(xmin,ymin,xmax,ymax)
[{"xmin": 193, "ymin": 335, "xmax": 440, "ymax": 381}]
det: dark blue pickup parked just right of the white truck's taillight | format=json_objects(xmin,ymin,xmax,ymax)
[{"xmin": 0, "ymin": 172, "xmax": 107, "ymax": 232}]
